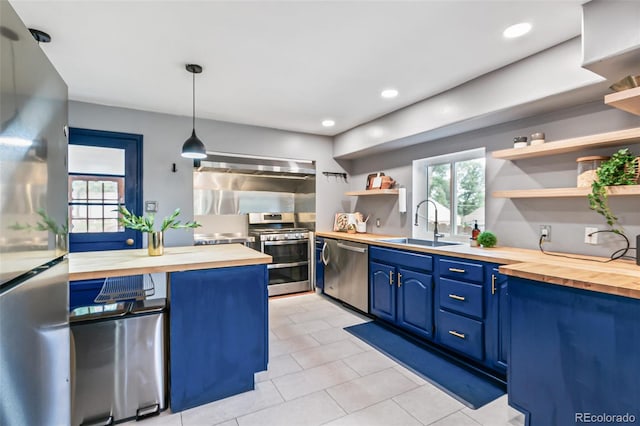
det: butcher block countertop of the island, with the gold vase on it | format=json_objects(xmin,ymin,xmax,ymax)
[{"xmin": 69, "ymin": 244, "xmax": 271, "ymax": 281}]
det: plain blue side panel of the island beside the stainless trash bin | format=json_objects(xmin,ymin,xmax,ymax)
[{"xmin": 169, "ymin": 265, "xmax": 268, "ymax": 412}]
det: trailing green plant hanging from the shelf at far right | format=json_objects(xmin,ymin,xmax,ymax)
[{"xmin": 588, "ymin": 148, "xmax": 638, "ymax": 234}]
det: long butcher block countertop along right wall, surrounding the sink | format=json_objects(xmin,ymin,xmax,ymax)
[{"xmin": 316, "ymin": 232, "xmax": 640, "ymax": 299}]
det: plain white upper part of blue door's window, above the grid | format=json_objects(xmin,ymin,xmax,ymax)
[{"xmin": 69, "ymin": 145, "xmax": 124, "ymax": 176}]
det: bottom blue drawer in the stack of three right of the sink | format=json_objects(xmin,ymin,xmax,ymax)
[{"xmin": 436, "ymin": 309, "xmax": 484, "ymax": 360}]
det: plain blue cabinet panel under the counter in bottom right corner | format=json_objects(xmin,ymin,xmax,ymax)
[{"xmin": 507, "ymin": 277, "xmax": 640, "ymax": 426}]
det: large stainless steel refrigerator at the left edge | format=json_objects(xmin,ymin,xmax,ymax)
[{"xmin": 0, "ymin": 0, "xmax": 71, "ymax": 426}]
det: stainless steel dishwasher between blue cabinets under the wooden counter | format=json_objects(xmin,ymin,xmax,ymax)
[{"xmin": 322, "ymin": 238, "xmax": 369, "ymax": 313}]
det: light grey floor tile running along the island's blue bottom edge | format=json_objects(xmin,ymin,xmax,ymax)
[{"xmin": 182, "ymin": 382, "xmax": 282, "ymax": 426}]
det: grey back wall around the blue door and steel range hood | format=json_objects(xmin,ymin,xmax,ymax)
[{"xmin": 69, "ymin": 102, "xmax": 348, "ymax": 246}]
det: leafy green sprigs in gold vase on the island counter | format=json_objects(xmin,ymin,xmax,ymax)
[{"xmin": 118, "ymin": 206, "xmax": 202, "ymax": 256}]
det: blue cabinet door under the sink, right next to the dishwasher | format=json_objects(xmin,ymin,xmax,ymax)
[{"xmin": 369, "ymin": 262, "xmax": 396, "ymax": 322}]
